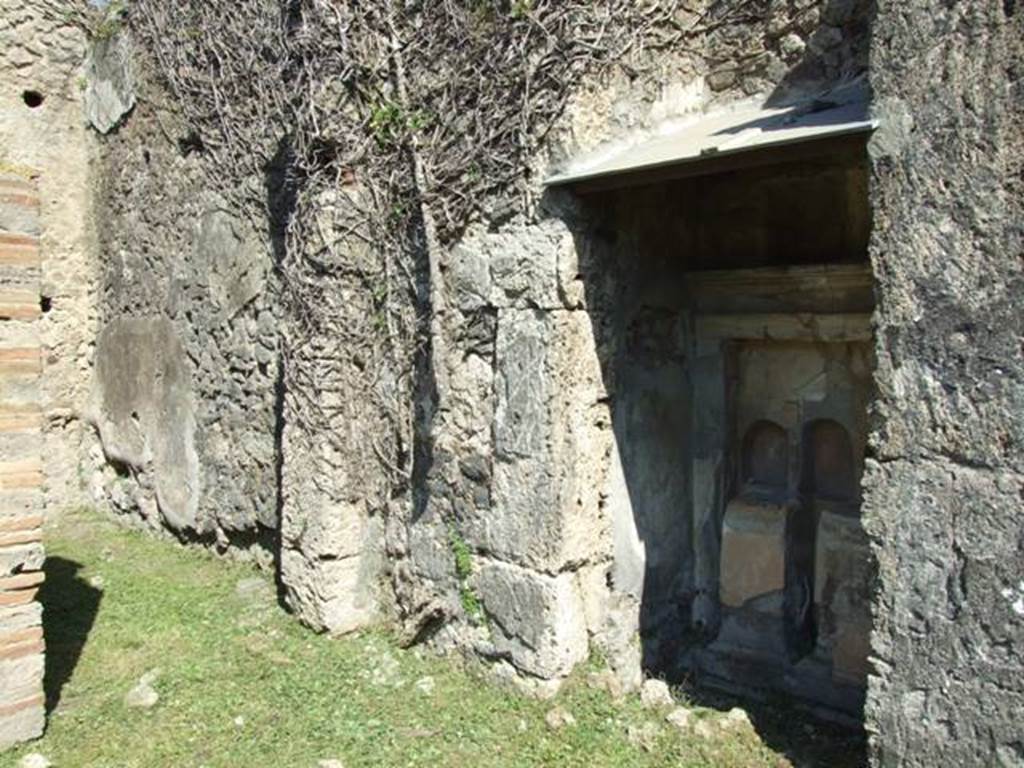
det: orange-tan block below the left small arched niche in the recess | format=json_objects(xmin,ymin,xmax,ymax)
[{"xmin": 719, "ymin": 499, "xmax": 786, "ymax": 608}]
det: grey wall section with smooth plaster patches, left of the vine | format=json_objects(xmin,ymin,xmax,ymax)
[{"xmin": 86, "ymin": 46, "xmax": 279, "ymax": 552}]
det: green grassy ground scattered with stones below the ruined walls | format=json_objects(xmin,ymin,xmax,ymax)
[{"xmin": 0, "ymin": 512, "xmax": 858, "ymax": 768}]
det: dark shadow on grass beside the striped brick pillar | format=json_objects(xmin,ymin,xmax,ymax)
[{"xmin": 39, "ymin": 557, "xmax": 102, "ymax": 715}]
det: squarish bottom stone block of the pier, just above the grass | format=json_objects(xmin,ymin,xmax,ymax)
[{"xmin": 474, "ymin": 560, "xmax": 589, "ymax": 679}]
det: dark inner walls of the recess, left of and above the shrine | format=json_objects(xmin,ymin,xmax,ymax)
[{"xmin": 583, "ymin": 138, "xmax": 872, "ymax": 673}]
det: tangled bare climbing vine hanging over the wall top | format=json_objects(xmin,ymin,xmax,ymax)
[{"xmin": 66, "ymin": 0, "xmax": 751, "ymax": 512}]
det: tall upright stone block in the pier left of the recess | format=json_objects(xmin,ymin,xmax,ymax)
[{"xmin": 464, "ymin": 309, "xmax": 611, "ymax": 572}]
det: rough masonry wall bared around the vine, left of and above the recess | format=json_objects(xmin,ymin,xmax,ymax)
[{"xmin": 79, "ymin": 0, "xmax": 870, "ymax": 682}]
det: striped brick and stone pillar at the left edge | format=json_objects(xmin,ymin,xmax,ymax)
[{"xmin": 0, "ymin": 173, "xmax": 45, "ymax": 750}]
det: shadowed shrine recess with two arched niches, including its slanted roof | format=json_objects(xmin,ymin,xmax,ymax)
[{"xmin": 553, "ymin": 87, "xmax": 873, "ymax": 722}]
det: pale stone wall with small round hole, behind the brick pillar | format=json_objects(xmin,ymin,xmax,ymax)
[{"xmin": 0, "ymin": 0, "xmax": 97, "ymax": 520}]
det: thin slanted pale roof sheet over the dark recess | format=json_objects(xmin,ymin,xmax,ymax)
[{"xmin": 545, "ymin": 87, "xmax": 878, "ymax": 186}]
